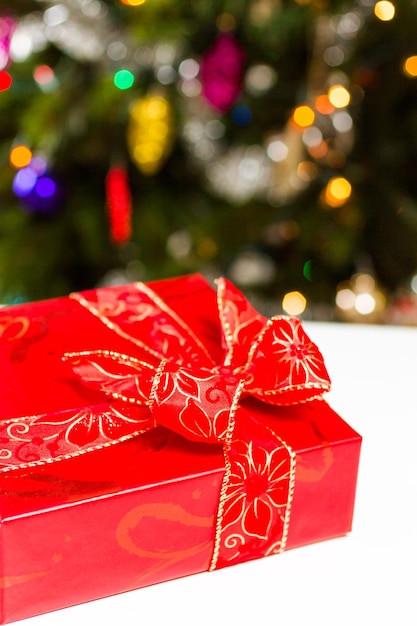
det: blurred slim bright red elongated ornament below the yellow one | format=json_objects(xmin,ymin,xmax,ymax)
[{"xmin": 106, "ymin": 165, "xmax": 132, "ymax": 245}]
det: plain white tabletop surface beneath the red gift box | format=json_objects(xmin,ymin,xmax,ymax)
[{"xmin": 13, "ymin": 323, "xmax": 417, "ymax": 626}]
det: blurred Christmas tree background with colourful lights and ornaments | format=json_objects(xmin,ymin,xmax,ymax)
[{"xmin": 0, "ymin": 0, "xmax": 417, "ymax": 325}]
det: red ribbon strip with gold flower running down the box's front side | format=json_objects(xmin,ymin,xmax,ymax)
[{"xmin": 210, "ymin": 407, "xmax": 296, "ymax": 569}]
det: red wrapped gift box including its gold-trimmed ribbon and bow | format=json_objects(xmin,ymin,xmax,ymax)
[{"xmin": 0, "ymin": 275, "xmax": 361, "ymax": 623}]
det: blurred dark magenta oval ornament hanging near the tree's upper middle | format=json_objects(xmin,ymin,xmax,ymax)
[{"xmin": 200, "ymin": 33, "xmax": 245, "ymax": 113}]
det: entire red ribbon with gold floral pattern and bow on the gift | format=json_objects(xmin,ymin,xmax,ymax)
[{"xmin": 0, "ymin": 278, "xmax": 330, "ymax": 569}]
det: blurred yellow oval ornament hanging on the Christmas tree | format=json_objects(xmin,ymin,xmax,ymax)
[{"xmin": 127, "ymin": 94, "xmax": 174, "ymax": 176}]
